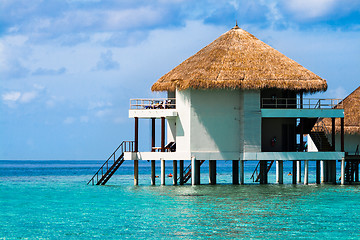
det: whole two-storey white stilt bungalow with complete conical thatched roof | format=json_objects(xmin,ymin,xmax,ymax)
[{"xmin": 88, "ymin": 25, "xmax": 354, "ymax": 185}]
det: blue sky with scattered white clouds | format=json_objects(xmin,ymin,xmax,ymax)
[{"xmin": 0, "ymin": 0, "xmax": 360, "ymax": 160}]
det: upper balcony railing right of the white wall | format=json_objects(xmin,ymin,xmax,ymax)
[{"xmin": 261, "ymin": 98, "xmax": 343, "ymax": 109}]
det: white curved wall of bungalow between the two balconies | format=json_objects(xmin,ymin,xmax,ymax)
[{"xmin": 176, "ymin": 89, "xmax": 261, "ymax": 160}]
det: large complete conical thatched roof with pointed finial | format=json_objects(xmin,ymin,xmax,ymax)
[{"xmin": 151, "ymin": 26, "xmax": 327, "ymax": 92}]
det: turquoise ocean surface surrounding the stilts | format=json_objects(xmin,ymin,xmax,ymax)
[{"xmin": 0, "ymin": 161, "xmax": 360, "ymax": 239}]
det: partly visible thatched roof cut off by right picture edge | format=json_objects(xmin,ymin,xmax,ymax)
[{"xmin": 323, "ymin": 86, "xmax": 360, "ymax": 134}]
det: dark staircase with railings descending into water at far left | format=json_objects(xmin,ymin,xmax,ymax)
[{"xmin": 87, "ymin": 141, "xmax": 135, "ymax": 185}]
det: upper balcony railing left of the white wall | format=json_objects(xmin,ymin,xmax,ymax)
[{"xmin": 130, "ymin": 98, "xmax": 176, "ymax": 110}]
